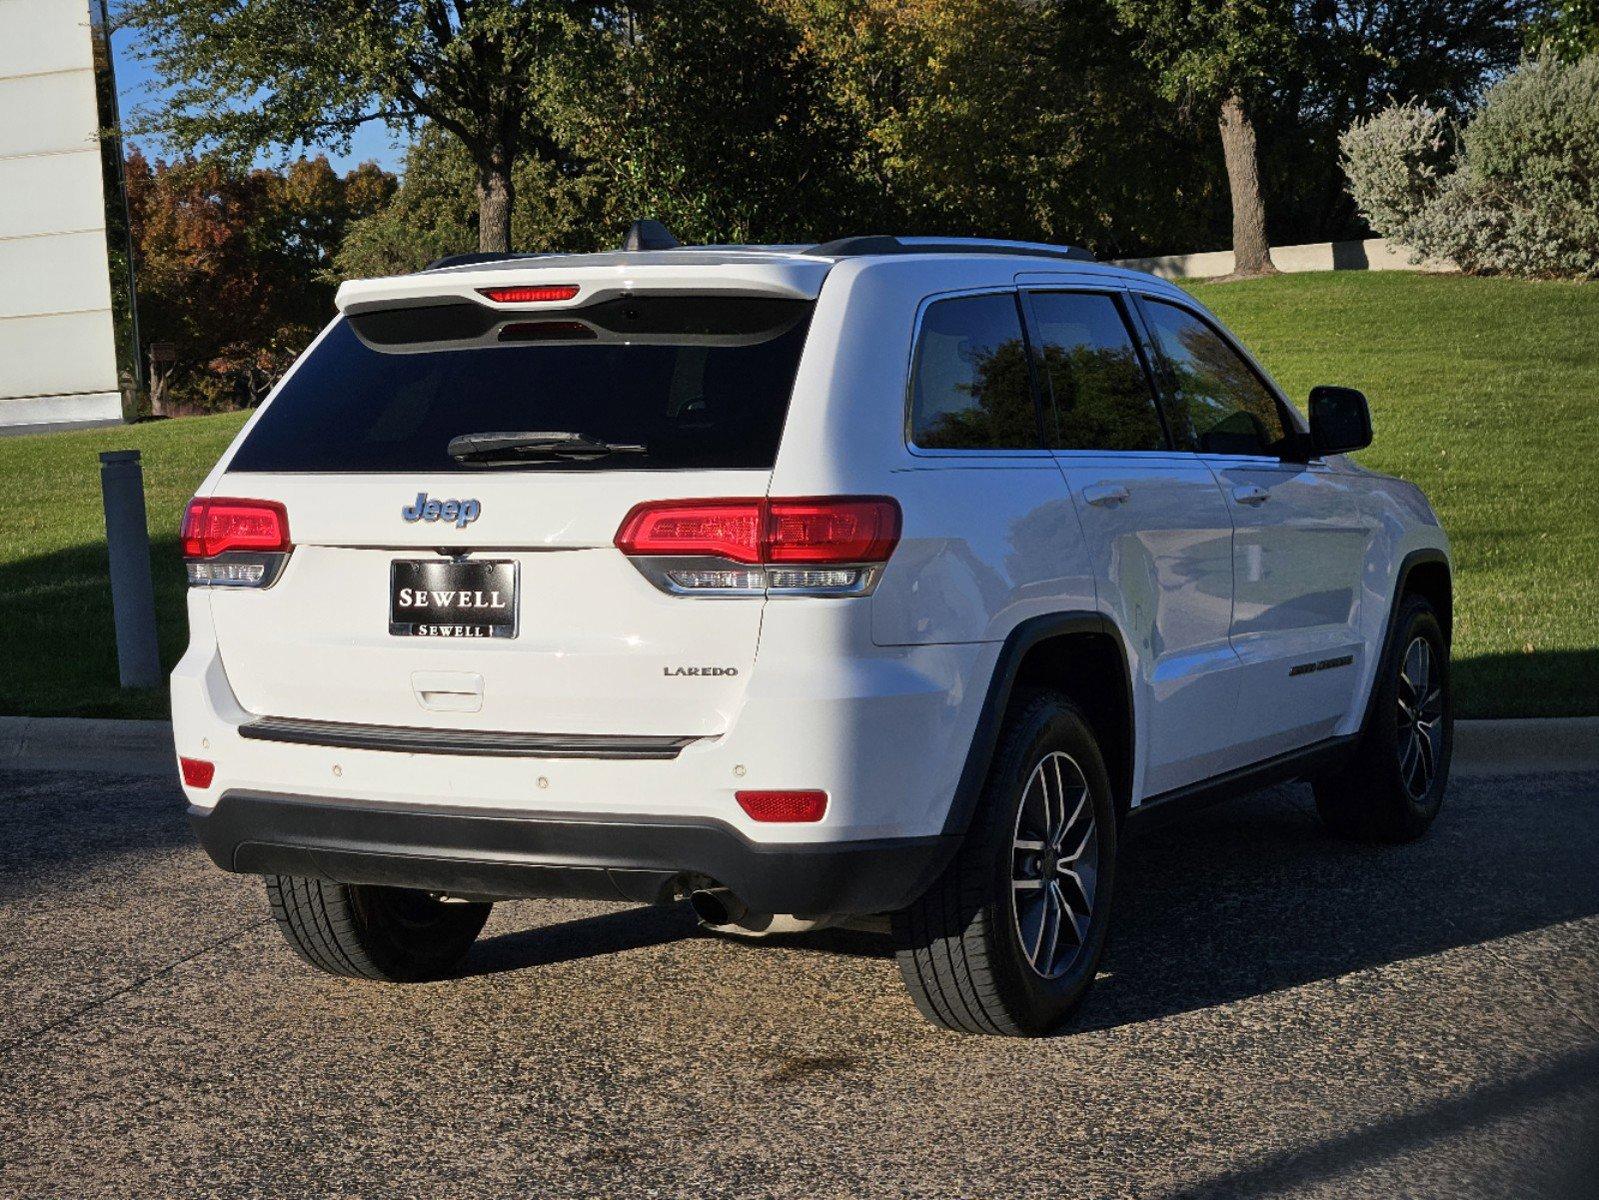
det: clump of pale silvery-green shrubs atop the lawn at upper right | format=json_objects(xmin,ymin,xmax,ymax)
[{"xmin": 1342, "ymin": 54, "xmax": 1599, "ymax": 278}]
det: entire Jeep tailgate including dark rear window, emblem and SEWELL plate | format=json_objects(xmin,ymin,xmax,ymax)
[{"xmin": 196, "ymin": 284, "xmax": 814, "ymax": 736}]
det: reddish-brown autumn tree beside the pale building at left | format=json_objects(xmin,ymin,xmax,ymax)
[{"xmin": 126, "ymin": 149, "xmax": 395, "ymax": 414}]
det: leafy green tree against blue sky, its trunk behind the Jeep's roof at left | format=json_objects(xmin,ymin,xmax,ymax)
[{"xmin": 120, "ymin": 0, "xmax": 601, "ymax": 250}]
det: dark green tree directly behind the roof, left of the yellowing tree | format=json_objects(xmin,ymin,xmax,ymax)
[{"xmin": 558, "ymin": 0, "xmax": 876, "ymax": 242}]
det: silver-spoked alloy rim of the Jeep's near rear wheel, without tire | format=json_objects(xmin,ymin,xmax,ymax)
[{"xmin": 1011, "ymin": 750, "xmax": 1099, "ymax": 979}]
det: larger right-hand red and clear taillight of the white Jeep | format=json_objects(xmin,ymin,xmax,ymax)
[{"xmin": 616, "ymin": 496, "xmax": 900, "ymax": 595}]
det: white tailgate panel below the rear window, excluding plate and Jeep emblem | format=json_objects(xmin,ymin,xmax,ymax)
[{"xmin": 201, "ymin": 472, "xmax": 769, "ymax": 736}]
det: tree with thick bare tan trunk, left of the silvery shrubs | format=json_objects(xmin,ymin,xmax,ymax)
[{"xmin": 1115, "ymin": 0, "xmax": 1298, "ymax": 275}]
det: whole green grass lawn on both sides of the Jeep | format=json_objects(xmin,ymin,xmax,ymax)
[{"xmin": 0, "ymin": 272, "xmax": 1599, "ymax": 717}]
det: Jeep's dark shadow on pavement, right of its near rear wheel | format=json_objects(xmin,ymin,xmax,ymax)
[{"xmin": 1076, "ymin": 774, "xmax": 1599, "ymax": 1030}]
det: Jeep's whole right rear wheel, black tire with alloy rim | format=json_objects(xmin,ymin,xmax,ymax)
[{"xmin": 894, "ymin": 691, "xmax": 1116, "ymax": 1037}]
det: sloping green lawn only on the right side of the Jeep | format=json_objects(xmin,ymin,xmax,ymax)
[{"xmin": 1190, "ymin": 272, "xmax": 1599, "ymax": 717}]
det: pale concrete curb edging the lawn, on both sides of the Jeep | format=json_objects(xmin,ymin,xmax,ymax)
[{"xmin": 0, "ymin": 717, "xmax": 1599, "ymax": 782}]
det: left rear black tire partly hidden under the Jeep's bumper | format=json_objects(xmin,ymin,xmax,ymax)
[{"xmin": 267, "ymin": 875, "xmax": 494, "ymax": 982}]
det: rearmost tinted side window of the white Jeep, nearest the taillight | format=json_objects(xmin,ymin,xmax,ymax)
[{"xmin": 911, "ymin": 291, "xmax": 1039, "ymax": 450}]
